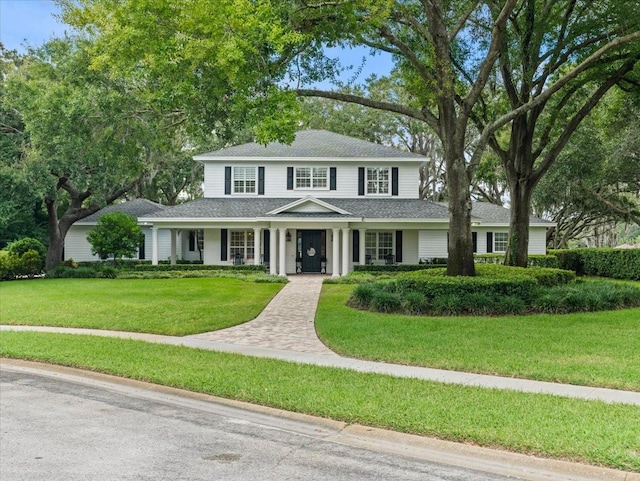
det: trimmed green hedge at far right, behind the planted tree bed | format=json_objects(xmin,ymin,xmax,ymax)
[{"xmin": 551, "ymin": 248, "xmax": 640, "ymax": 281}]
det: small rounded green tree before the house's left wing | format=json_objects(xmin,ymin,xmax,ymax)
[{"xmin": 87, "ymin": 212, "xmax": 144, "ymax": 262}]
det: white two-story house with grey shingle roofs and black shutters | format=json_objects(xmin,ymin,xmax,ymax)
[{"xmin": 65, "ymin": 130, "xmax": 553, "ymax": 276}]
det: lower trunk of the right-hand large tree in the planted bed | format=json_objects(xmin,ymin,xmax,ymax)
[{"xmin": 504, "ymin": 178, "xmax": 535, "ymax": 267}]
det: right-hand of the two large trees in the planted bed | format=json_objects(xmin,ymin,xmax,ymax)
[{"xmin": 474, "ymin": 0, "xmax": 640, "ymax": 266}]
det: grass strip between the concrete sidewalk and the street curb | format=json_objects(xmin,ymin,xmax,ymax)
[{"xmin": 0, "ymin": 331, "xmax": 640, "ymax": 471}]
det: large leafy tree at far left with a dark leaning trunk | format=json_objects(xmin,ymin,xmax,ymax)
[{"xmin": 5, "ymin": 38, "xmax": 161, "ymax": 270}]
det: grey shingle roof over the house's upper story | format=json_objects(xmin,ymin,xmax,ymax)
[{"xmin": 194, "ymin": 130, "xmax": 424, "ymax": 161}]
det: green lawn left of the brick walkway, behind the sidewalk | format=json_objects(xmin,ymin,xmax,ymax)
[{"xmin": 0, "ymin": 278, "xmax": 284, "ymax": 336}]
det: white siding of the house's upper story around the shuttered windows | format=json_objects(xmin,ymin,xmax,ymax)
[{"xmin": 204, "ymin": 159, "xmax": 419, "ymax": 199}]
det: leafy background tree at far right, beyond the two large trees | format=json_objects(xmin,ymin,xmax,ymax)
[{"xmin": 533, "ymin": 90, "xmax": 640, "ymax": 248}]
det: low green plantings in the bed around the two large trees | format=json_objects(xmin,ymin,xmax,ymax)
[{"xmin": 349, "ymin": 264, "xmax": 640, "ymax": 315}]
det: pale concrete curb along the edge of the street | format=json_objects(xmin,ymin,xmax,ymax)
[{"xmin": 0, "ymin": 358, "xmax": 640, "ymax": 481}]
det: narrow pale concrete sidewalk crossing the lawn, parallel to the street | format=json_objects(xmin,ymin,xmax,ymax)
[{"xmin": 0, "ymin": 325, "xmax": 640, "ymax": 406}]
